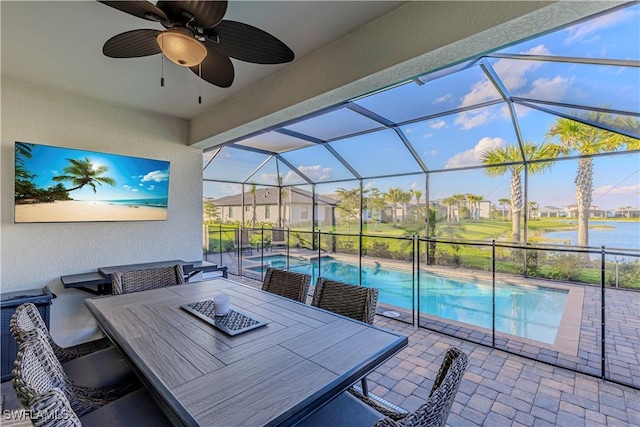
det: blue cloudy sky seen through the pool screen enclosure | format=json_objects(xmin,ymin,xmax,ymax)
[{"xmin": 204, "ymin": 4, "xmax": 640, "ymax": 209}]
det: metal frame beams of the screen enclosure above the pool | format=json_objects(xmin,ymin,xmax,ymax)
[{"xmin": 203, "ymin": 4, "xmax": 640, "ymax": 247}]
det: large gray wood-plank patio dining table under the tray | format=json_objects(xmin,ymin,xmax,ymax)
[{"xmin": 86, "ymin": 278, "xmax": 408, "ymax": 426}]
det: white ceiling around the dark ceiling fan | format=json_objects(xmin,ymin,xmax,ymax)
[{"xmin": 0, "ymin": 0, "xmax": 402, "ymax": 119}]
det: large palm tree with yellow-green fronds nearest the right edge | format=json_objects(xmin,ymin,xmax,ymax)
[{"xmin": 547, "ymin": 111, "xmax": 640, "ymax": 246}]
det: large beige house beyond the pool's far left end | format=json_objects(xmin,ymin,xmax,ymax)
[{"xmin": 215, "ymin": 187, "xmax": 339, "ymax": 227}]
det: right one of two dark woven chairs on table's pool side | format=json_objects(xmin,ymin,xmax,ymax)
[{"xmin": 311, "ymin": 277, "xmax": 378, "ymax": 396}]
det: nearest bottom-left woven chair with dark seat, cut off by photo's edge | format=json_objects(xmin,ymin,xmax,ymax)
[{"xmin": 28, "ymin": 388, "xmax": 172, "ymax": 427}]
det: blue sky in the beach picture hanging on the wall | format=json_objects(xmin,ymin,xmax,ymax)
[{"xmin": 18, "ymin": 144, "xmax": 169, "ymax": 201}]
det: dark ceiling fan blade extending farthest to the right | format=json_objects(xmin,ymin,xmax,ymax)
[{"xmin": 204, "ymin": 20, "xmax": 295, "ymax": 64}]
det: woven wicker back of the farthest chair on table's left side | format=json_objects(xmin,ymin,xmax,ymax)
[{"xmin": 9, "ymin": 303, "xmax": 95, "ymax": 363}]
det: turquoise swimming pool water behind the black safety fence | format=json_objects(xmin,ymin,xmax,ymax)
[{"xmin": 285, "ymin": 257, "xmax": 569, "ymax": 344}]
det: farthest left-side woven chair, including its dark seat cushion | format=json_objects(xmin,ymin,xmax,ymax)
[{"xmin": 9, "ymin": 303, "xmax": 138, "ymax": 388}]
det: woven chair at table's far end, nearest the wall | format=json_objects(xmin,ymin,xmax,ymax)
[{"xmin": 111, "ymin": 264, "xmax": 185, "ymax": 295}]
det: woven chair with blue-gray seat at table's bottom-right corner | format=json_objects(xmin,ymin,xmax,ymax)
[{"xmin": 297, "ymin": 347, "xmax": 467, "ymax": 427}]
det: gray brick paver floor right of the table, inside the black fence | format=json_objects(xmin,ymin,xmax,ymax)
[{"xmin": 225, "ymin": 276, "xmax": 640, "ymax": 427}]
